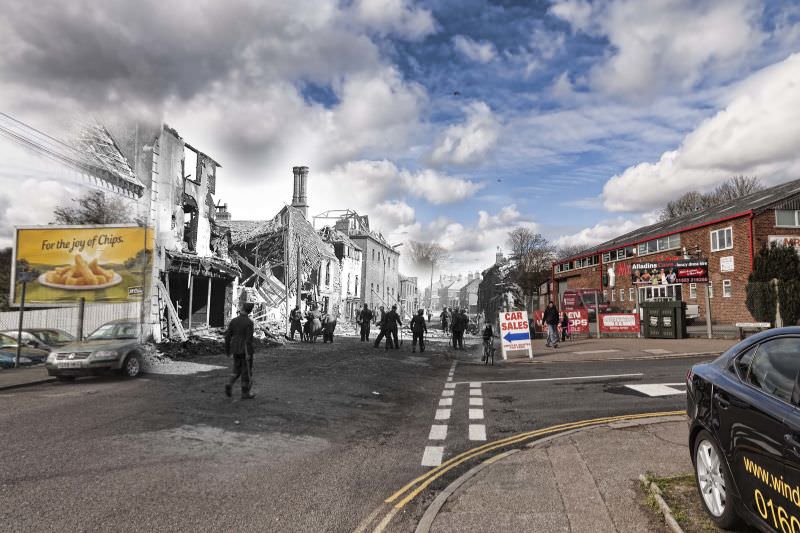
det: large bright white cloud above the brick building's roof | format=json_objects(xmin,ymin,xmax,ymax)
[{"xmin": 602, "ymin": 54, "xmax": 800, "ymax": 211}]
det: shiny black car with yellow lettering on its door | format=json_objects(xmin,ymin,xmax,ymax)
[{"xmin": 686, "ymin": 327, "xmax": 800, "ymax": 533}]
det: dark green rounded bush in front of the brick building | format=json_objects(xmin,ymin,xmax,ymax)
[{"xmin": 745, "ymin": 243, "xmax": 800, "ymax": 325}]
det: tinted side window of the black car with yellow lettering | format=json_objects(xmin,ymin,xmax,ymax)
[{"xmin": 747, "ymin": 338, "xmax": 800, "ymax": 402}]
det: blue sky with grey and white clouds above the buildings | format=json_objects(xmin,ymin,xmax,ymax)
[{"xmin": 0, "ymin": 0, "xmax": 800, "ymax": 280}]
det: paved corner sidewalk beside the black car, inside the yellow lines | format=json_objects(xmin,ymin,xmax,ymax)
[{"xmin": 417, "ymin": 417, "xmax": 692, "ymax": 533}]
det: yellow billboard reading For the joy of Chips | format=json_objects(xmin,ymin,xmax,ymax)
[{"xmin": 10, "ymin": 225, "xmax": 154, "ymax": 305}]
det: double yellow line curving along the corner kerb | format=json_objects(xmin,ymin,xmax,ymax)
[{"xmin": 384, "ymin": 411, "xmax": 686, "ymax": 510}]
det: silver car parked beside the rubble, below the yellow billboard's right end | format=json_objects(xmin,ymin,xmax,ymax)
[{"xmin": 45, "ymin": 318, "xmax": 142, "ymax": 381}]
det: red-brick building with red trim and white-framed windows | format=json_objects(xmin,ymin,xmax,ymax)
[{"xmin": 552, "ymin": 180, "xmax": 800, "ymax": 324}]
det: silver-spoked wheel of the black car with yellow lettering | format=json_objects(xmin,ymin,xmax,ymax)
[{"xmin": 694, "ymin": 430, "xmax": 739, "ymax": 529}]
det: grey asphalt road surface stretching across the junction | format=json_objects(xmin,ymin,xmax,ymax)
[{"xmin": 0, "ymin": 339, "xmax": 712, "ymax": 532}]
